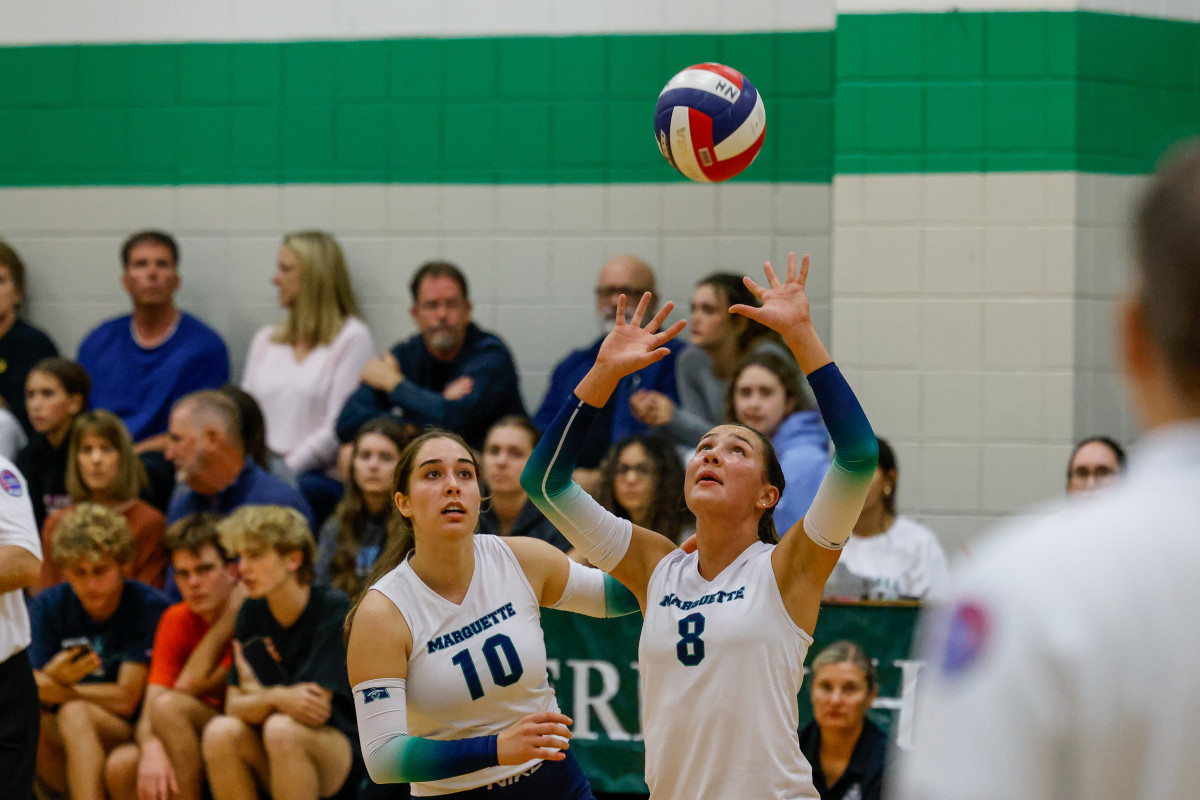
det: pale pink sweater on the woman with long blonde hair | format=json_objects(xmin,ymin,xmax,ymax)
[{"xmin": 241, "ymin": 317, "xmax": 374, "ymax": 475}]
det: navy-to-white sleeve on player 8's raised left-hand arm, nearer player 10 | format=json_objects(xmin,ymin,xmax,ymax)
[{"xmin": 521, "ymin": 396, "xmax": 634, "ymax": 572}]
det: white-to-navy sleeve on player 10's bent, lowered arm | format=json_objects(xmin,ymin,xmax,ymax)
[{"xmin": 354, "ymin": 678, "xmax": 499, "ymax": 783}]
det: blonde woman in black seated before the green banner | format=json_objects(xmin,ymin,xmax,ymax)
[{"xmin": 800, "ymin": 640, "xmax": 888, "ymax": 800}]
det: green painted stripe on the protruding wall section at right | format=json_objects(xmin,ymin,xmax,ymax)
[{"xmin": 834, "ymin": 12, "xmax": 1200, "ymax": 174}]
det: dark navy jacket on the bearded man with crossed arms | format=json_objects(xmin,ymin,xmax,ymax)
[{"xmin": 337, "ymin": 323, "xmax": 524, "ymax": 450}]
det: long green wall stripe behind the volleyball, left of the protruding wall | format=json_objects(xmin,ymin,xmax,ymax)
[{"xmin": 0, "ymin": 31, "xmax": 833, "ymax": 186}]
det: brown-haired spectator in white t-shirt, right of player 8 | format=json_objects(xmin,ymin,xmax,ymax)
[{"xmin": 840, "ymin": 437, "xmax": 949, "ymax": 600}]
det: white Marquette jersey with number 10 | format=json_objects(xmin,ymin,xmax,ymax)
[{"xmin": 371, "ymin": 536, "xmax": 558, "ymax": 796}]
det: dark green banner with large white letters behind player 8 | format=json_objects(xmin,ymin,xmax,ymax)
[{"xmin": 542, "ymin": 603, "xmax": 922, "ymax": 793}]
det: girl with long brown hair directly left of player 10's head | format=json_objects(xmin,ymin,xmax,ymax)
[{"xmin": 316, "ymin": 417, "xmax": 408, "ymax": 597}]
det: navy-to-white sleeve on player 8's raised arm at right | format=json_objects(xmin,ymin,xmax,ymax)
[{"xmin": 804, "ymin": 361, "xmax": 880, "ymax": 551}]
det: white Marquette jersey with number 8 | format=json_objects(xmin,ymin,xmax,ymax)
[{"xmin": 638, "ymin": 542, "xmax": 818, "ymax": 800}]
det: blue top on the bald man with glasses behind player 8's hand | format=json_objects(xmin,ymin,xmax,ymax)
[{"xmin": 533, "ymin": 336, "xmax": 685, "ymax": 469}]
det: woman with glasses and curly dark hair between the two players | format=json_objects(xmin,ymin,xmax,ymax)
[{"xmin": 595, "ymin": 434, "xmax": 696, "ymax": 545}]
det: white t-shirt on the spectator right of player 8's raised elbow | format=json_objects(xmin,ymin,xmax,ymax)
[{"xmin": 840, "ymin": 517, "xmax": 950, "ymax": 600}]
